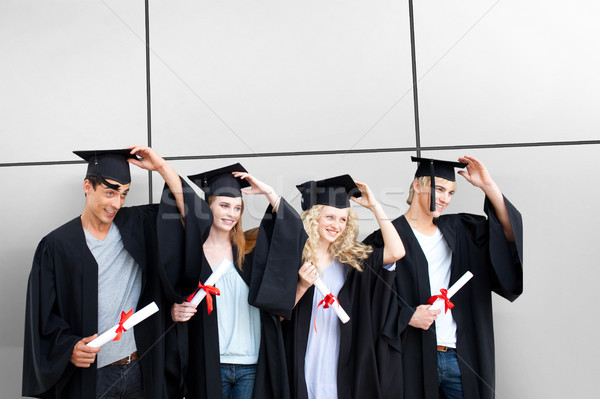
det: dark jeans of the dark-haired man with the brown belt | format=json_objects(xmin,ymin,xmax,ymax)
[{"xmin": 96, "ymin": 361, "xmax": 144, "ymax": 399}]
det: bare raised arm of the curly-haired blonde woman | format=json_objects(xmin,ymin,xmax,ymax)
[{"xmin": 352, "ymin": 182, "xmax": 406, "ymax": 264}]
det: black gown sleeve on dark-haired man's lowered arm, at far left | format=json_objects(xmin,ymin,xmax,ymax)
[{"xmin": 22, "ymin": 237, "xmax": 81, "ymax": 396}]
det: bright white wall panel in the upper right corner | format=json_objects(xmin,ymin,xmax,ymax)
[{"xmin": 415, "ymin": 0, "xmax": 600, "ymax": 146}]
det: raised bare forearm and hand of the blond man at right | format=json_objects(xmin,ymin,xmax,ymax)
[{"xmin": 458, "ymin": 155, "xmax": 515, "ymax": 242}]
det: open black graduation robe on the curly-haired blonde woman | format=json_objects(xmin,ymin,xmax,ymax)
[{"xmin": 282, "ymin": 249, "xmax": 402, "ymax": 399}]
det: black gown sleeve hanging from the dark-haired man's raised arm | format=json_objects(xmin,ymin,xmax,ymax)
[{"xmin": 157, "ymin": 179, "xmax": 213, "ymax": 303}]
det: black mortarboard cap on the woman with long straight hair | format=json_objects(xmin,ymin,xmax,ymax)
[{"xmin": 188, "ymin": 163, "xmax": 250, "ymax": 198}]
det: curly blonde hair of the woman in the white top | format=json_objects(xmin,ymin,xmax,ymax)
[{"xmin": 302, "ymin": 205, "xmax": 373, "ymax": 272}]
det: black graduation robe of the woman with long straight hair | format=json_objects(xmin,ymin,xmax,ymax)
[{"xmin": 161, "ymin": 197, "xmax": 306, "ymax": 399}]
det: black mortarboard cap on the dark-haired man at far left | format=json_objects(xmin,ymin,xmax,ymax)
[{"xmin": 73, "ymin": 148, "xmax": 137, "ymax": 190}]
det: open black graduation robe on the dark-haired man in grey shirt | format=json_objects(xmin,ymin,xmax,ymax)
[{"xmin": 22, "ymin": 182, "xmax": 197, "ymax": 399}]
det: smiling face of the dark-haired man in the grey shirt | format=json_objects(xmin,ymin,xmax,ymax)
[{"xmin": 83, "ymin": 179, "xmax": 130, "ymax": 224}]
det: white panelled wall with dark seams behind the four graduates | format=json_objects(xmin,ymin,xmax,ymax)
[{"xmin": 0, "ymin": 0, "xmax": 600, "ymax": 398}]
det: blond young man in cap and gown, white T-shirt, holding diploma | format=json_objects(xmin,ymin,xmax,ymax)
[{"xmin": 365, "ymin": 156, "xmax": 523, "ymax": 399}]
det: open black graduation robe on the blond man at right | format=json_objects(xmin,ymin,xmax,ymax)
[{"xmin": 364, "ymin": 198, "xmax": 523, "ymax": 399}]
